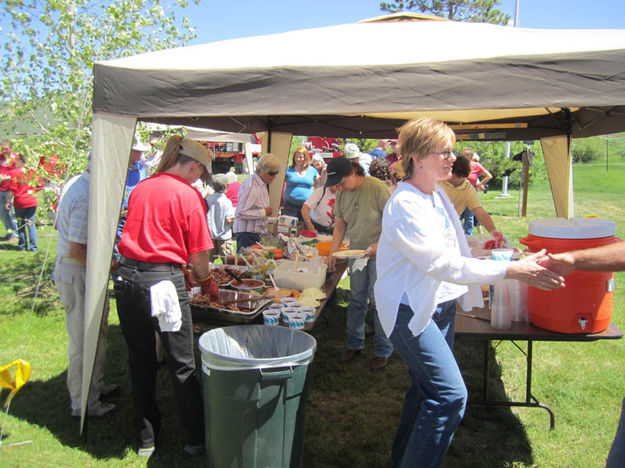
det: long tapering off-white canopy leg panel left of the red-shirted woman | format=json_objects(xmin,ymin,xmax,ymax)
[{"xmin": 80, "ymin": 113, "xmax": 136, "ymax": 433}]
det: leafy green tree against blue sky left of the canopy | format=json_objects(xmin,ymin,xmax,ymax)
[{"xmin": 0, "ymin": 0, "xmax": 199, "ymax": 180}]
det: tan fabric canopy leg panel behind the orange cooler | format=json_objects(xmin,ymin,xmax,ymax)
[{"xmin": 540, "ymin": 135, "xmax": 575, "ymax": 218}]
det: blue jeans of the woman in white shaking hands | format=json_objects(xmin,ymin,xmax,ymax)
[{"xmin": 391, "ymin": 301, "xmax": 467, "ymax": 468}]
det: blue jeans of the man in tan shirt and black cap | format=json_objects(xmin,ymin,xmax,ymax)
[{"xmin": 346, "ymin": 256, "xmax": 393, "ymax": 357}]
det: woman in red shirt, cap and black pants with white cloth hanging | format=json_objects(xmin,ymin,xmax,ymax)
[{"xmin": 115, "ymin": 135, "xmax": 219, "ymax": 457}]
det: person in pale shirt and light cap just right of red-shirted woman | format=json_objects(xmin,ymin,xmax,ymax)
[{"xmin": 205, "ymin": 174, "xmax": 234, "ymax": 261}]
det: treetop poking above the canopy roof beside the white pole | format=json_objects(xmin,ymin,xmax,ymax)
[{"xmin": 380, "ymin": 0, "xmax": 510, "ymax": 24}]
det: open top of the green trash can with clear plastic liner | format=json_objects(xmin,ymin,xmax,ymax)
[{"xmin": 199, "ymin": 325, "xmax": 317, "ymax": 368}]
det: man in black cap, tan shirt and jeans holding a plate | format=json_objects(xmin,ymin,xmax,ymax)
[{"xmin": 326, "ymin": 157, "xmax": 393, "ymax": 370}]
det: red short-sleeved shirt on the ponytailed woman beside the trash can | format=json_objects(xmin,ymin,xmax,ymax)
[{"xmin": 117, "ymin": 172, "xmax": 213, "ymax": 265}]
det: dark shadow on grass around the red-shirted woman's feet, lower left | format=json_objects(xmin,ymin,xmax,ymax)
[{"xmin": 5, "ymin": 325, "xmax": 204, "ymax": 468}]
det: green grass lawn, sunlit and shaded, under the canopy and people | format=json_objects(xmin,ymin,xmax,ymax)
[{"xmin": 0, "ymin": 159, "xmax": 625, "ymax": 468}]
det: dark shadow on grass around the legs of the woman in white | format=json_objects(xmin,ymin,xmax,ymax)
[{"xmin": 304, "ymin": 288, "xmax": 533, "ymax": 468}]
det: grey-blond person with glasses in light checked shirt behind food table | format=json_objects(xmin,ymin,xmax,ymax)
[{"xmin": 233, "ymin": 153, "xmax": 280, "ymax": 253}]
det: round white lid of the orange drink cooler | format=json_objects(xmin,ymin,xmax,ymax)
[{"xmin": 529, "ymin": 218, "xmax": 616, "ymax": 239}]
